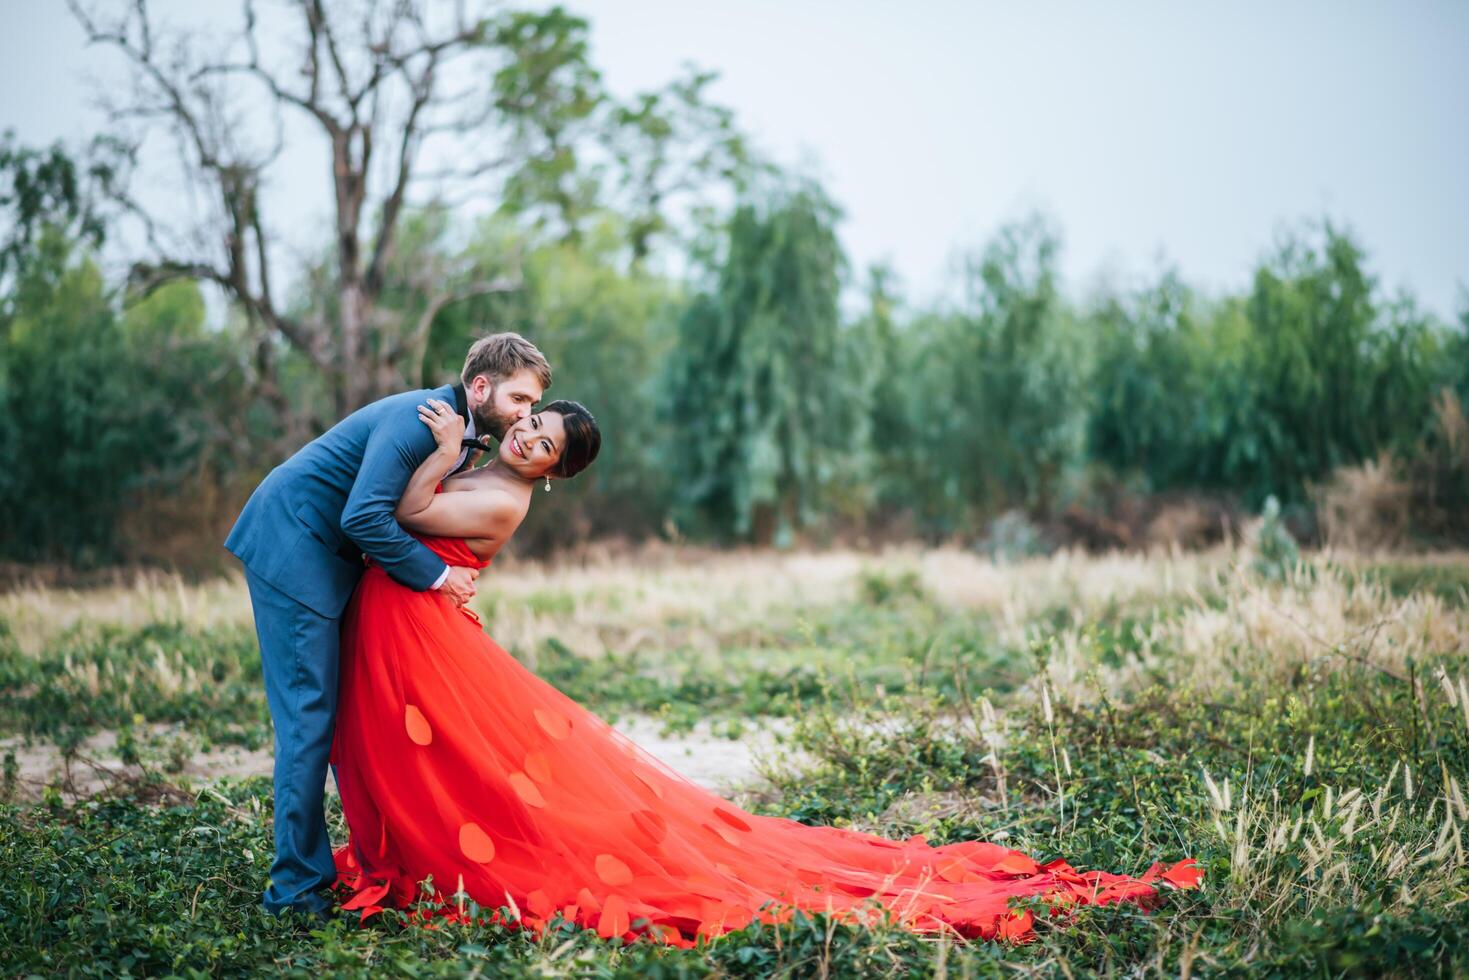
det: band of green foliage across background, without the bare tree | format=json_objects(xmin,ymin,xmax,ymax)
[{"xmin": 0, "ymin": 184, "xmax": 1469, "ymax": 566}]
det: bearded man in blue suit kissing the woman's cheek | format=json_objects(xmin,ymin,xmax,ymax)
[{"xmin": 225, "ymin": 334, "xmax": 551, "ymax": 917}]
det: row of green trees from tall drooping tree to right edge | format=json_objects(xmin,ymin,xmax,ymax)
[{"xmin": 667, "ymin": 198, "xmax": 1469, "ymax": 547}]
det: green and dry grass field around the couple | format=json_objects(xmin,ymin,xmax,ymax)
[{"xmin": 0, "ymin": 551, "xmax": 1469, "ymax": 977}]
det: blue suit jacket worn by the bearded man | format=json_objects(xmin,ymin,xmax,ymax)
[{"xmin": 225, "ymin": 385, "xmax": 464, "ymax": 619}]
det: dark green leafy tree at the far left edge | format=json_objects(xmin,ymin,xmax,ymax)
[{"xmin": 0, "ymin": 226, "xmax": 238, "ymax": 566}]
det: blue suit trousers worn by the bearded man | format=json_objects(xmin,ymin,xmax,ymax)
[{"xmin": 245, "ymin": 569, "xmax": 341, "ymax": 914}]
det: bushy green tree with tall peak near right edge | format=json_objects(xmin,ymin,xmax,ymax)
[{"xmin": 1203, "ymin": 222, "xmax": 1441, "ymax": 504}]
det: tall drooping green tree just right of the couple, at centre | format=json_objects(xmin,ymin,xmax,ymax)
[{"xmin": 670, "ymin": 184, "xmax": 856, "ymax": 544}]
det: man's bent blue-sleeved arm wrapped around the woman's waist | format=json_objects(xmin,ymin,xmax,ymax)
[{"xmin": 342, "ymin": 414, "xmax": 448, "ymax": 592}]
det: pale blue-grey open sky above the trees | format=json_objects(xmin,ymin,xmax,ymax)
[{"xmin": 0, "ymin": 0, "xmax": 1469, "ymax": 316}]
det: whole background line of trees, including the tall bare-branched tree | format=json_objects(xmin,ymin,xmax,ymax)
[{"xmin": 0, "ymin": 3, "xmax": 1469, "ymax": 569}]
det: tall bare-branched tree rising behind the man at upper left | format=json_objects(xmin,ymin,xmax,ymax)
[{"xmin": 69, "ymin": 0, "xmax": 585, "ymax": 414}]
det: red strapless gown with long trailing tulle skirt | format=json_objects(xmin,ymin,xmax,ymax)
[{"xmin": 332, "ymin": 538, "xmax": 1199, "ymax": 945}]
